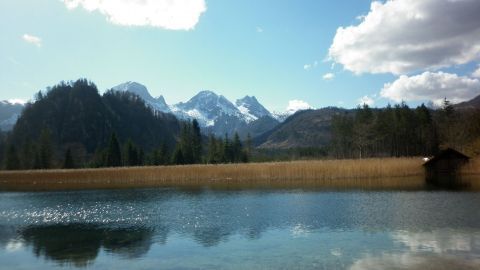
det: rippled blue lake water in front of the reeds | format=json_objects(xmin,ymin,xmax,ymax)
[{"xmin": 0, "ymin": 188, "xmax": 480, "ymax": 269}]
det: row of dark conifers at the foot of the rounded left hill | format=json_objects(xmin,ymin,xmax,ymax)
[{"xmin": 0, "ymin": 125, "xmax": 251, "ymax": 170}]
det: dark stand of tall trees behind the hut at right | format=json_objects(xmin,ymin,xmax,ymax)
[{"xmin": 329, "ymin": 99, "xmax": 480, "ymax": 158}]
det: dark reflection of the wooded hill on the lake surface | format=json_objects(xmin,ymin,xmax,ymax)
[{"xmin": 0, "ymin": 224, "xmax": 156, "ymax": 267}]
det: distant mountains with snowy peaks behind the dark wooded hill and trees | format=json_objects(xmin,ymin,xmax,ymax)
[{"xmin": 0, "ymin": 82, "xmax": 480, "ymax": 152}]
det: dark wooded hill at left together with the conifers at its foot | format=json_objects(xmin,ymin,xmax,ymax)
[{"xmin": 0, "ymin": 80, "xmax": 253, "ymax": 170}]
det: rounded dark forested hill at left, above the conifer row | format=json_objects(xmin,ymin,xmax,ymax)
[{"xmin": 9, "ymin": 80, "xmax": 180, "ymax": 168}]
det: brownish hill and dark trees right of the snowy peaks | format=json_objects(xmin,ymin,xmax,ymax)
[{"xmin": 254, "ymin": 102, "xmax": 480, "ymax": 158}]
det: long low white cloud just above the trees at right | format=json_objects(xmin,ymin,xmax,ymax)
[{"xmin": 380, "ymin": 71, "xmax": 480, "ymax": 105}]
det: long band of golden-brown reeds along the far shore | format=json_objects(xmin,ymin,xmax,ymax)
[{"xmin": 0, "ymin": 158, "xmax": 480, "ymax": 190}]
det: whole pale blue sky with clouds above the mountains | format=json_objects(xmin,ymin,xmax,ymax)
[{"xmin": 0, "ymin": 0, "xmax": 480, "ymax": 112}]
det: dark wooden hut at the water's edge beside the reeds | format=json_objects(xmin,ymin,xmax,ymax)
[{"xmin": 423, "ymin": 148, "xmax": 470, "ymax": 187}]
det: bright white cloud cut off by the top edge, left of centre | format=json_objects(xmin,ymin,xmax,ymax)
[{"xmin": 63, "ymin": 0, "xmax": 207, "ymax": 30}]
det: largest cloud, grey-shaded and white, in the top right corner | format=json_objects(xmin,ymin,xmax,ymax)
[{"xmin": 329, "ymin": 0, "xmax": 480, "ymax": 75}]
